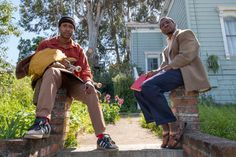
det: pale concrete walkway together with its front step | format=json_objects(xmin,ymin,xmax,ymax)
[{"xmin": 57, "ymin": 115, "xmax": 183, "ymax": 157}]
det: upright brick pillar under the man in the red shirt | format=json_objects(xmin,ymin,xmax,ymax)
[{"xmin": 50, "ymin": 89, "xmax": 72, "ymax": 146}]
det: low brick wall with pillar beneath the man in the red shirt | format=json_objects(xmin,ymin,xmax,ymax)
[{"xmin": 0, "ymin": 89, "xmax": 71, "ymax": 157}]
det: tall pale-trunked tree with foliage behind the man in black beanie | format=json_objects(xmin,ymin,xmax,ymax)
[{"xmin": 20, "ymin": 0, "xmax": 105, "ymax": 65}]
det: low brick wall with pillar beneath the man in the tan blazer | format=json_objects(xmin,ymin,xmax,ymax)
[{"xmin": 170, "ymin": 87, "xmax": 236, "ymax": 157}]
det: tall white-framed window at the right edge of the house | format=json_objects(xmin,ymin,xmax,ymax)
[{"xmin": 218, "ymin": 6, "xmax": 236, "ymax": 59}]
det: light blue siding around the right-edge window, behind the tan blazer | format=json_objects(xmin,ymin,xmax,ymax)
[{"xmin": 187, "ymin": 0, "xmax": 236, "ymax": 103}]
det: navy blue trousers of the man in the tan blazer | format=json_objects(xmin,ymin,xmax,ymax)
[{"xmin": 134, "ymin": 69, "xmax": 184, "ymax": 125}]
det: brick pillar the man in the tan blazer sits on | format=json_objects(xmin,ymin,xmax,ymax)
[{"xmin": 170, "ymin": 87, "xmax": 199, "ymax": 131}]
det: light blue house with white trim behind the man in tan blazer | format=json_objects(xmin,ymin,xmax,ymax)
[{"xmin": 127, "ymin": 0, "xmax": 236, "ymax": 103}]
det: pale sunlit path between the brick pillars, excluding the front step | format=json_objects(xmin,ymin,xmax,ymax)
[{"xmin": 78, "ymin": 114, "xmax": 161, "ymax": 148}]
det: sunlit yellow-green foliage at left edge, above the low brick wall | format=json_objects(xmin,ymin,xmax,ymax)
[{"xmin": 0, "ymin": 74, "xmax": 35, "ymax": 139}]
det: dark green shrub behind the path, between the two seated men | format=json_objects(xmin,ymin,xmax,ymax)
[{"xmin": 112, "ymin": 74, "xmax": 137, "ymax": 112}]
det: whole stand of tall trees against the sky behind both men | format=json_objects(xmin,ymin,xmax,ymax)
[{"xmin": 20, "ymin": 0, "xmax": 162, "ymax": 65}]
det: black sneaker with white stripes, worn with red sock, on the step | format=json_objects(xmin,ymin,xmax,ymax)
[{"xmin": 97, "ymin": 134, "xmax": 118, "ymax": 150}]
